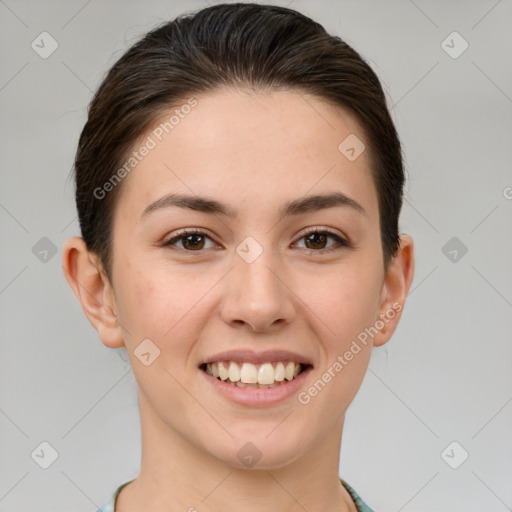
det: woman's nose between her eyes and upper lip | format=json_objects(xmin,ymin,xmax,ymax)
[{"xmin": 221, "ymin": 244, "xmax": 295, "ymax": 332}]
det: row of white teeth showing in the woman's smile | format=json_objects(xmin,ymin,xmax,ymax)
[{"xmin": 206, "ymin": 361, "xmax": 302, "ymax": 388}]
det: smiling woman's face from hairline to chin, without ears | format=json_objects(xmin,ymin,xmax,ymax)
[{"xmin": 79, "ymin": 89, "xmax": 408, "ymax": 468}]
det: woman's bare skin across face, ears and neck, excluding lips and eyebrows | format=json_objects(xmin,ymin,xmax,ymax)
[{"xmin": 63, "ymin": 89, "xmax": 414, "ymax": 512}]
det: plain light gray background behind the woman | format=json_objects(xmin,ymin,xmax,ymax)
[{"xmin": 0, "ymin": 0, "xmax": 512, "ymax": 512}]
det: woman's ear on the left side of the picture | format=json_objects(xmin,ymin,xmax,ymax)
[{"xmin": 62, "ymin": 236, "xmax": 124, "ymax": 348}]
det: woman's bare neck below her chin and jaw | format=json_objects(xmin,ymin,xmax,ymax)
[{"xmin": 115, "ymin": 393, "xmax": 356, "ymax": 512}]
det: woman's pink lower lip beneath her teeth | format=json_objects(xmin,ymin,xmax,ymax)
[{"xmin": 199, "ymin": 366, "xmax": 313, "ymax": 407}]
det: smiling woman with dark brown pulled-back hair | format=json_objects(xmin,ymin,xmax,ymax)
[{"xmin": 63, "ymin": 4, "xmax": 414, "ymax": 512}]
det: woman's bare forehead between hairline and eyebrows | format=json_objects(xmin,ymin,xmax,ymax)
[{"xmin": 114, "ymin": 88, "xmax": 376, "ymax": 222}]
